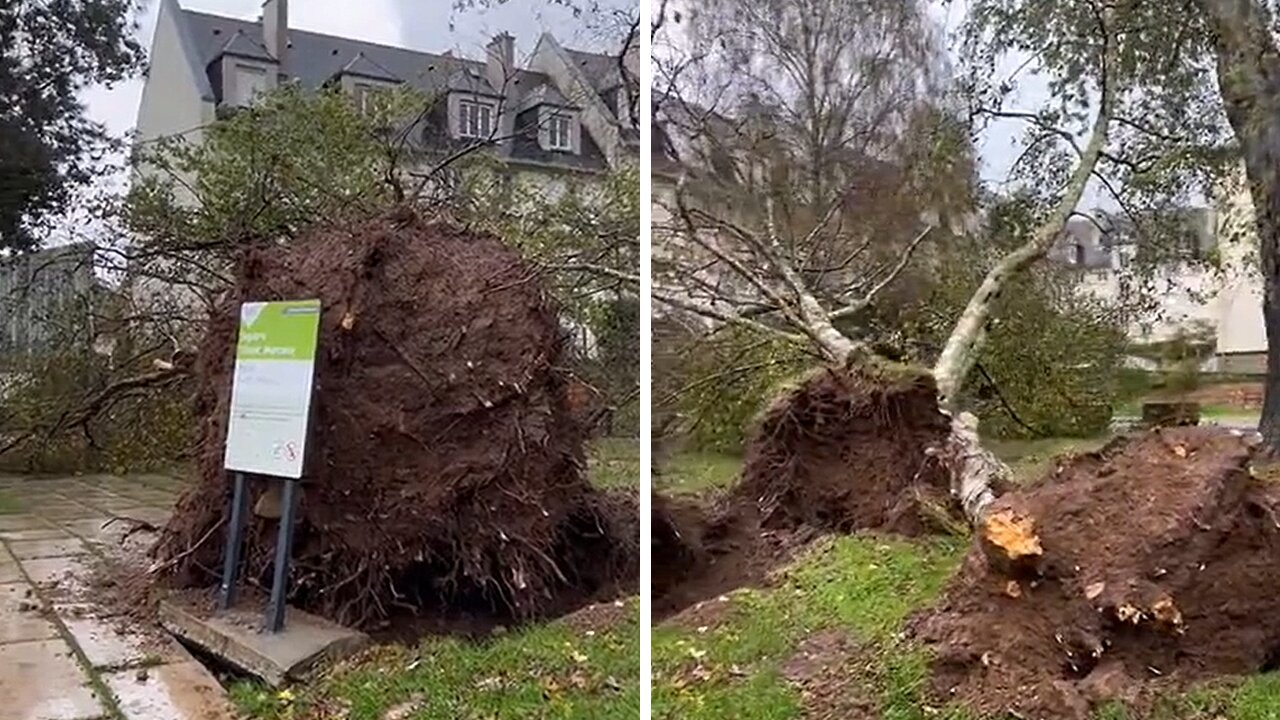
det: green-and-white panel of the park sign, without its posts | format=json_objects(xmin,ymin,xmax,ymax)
[{"xmin": 223, "ymin": 300, "xmax": 320, "ymax": 478}]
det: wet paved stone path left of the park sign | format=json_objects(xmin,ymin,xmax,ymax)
[{"xmin": 0, "ymin": 475, "xmax": 236, "ymax": 720}]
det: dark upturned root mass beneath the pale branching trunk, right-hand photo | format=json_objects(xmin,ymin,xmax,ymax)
[{"xmin": 733, "ymin": 368, "xmax": 951, "ymax": 534}]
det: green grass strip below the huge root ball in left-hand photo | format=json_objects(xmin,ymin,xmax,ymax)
[{"xmin": 230, "ymin": 600, "xmax": 640, "ymax": 720}]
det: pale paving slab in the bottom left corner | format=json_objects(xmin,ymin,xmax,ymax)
[{"xmin": 0, "ymin": 641, "xmax": 106, "ymax": 720}]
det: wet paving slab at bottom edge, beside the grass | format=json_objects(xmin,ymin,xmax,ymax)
[{"xmin": 104, "ymin": 662, "xmax": 237, "ymax": 720}]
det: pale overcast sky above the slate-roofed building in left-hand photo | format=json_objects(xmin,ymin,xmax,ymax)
[{"xmin": 83, "ymin": 0, "xmax": 637, "ymax": 146}]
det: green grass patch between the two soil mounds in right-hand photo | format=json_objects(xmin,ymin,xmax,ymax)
[{"xmin": 653, "ymin": 536, "xmax": 964, "ymax": 720}]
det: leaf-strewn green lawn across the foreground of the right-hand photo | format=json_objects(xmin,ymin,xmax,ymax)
[{"xmin": 653, "ymin": 534, "xmax": 1280, "ymax": 720}]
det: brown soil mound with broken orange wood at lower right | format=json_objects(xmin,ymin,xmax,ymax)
[{"xmin": 913, "ymin": 428, "xmax": 1280, "ymax": 719}]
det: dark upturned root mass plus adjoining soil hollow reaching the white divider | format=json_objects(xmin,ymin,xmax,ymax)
[{"xmin": 653, "ymin": 368, "xmax": 954, "ymax": 616}]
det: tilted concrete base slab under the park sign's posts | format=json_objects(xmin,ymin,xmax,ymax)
[{"xmin": 160, "ymin": 601, "xmax": 369, "ymax": 687}]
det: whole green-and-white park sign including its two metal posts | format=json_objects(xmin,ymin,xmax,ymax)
[{"xmin": 219, "ymin": 300, "xmax": 320, "ymax": 633}]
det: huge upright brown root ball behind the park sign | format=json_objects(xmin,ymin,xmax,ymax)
[{"xmin": 152, "ymin": 211, "xmax": 639, "ymax": 626}]
